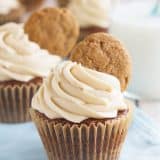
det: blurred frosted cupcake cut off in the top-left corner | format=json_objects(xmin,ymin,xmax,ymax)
[{"xmin": 0, "ymin": 0, "xmax": 25, "ymax": 24}]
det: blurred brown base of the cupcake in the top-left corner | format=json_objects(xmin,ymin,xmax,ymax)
[{"xmin": 0, "ymin": 7, "xmax": 24, "ymax": 25}]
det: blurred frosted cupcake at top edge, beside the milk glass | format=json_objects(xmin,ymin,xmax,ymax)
[{"xmin": 67, "ymin": 0, "xmax": 111, "ymax": 40}]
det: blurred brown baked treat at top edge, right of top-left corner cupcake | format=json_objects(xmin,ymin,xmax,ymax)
[{"xmin": 19, "ymin": 0, "xmax": 44, "ymax": 11}]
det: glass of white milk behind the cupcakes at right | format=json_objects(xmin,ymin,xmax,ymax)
[{"xmin": 110, "ymin": 1, "xmax": 160, "ymax": 100}]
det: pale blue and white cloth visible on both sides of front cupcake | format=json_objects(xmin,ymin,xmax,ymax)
[{"xmin": 0, "ymin": 109, "xmax": 160, "ymax": 160}]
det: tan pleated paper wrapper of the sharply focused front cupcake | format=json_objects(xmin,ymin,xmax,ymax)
[{"xmin": 30, "ymin": 105, "xmax": 131, "ymax": 160}]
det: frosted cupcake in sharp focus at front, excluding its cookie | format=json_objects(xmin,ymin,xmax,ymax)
[{"xmin": 30, "ymin": 61, "xmax": 132, "ymax": 160}]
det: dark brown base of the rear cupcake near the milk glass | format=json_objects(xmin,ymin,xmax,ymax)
[{"xmin": 79, "ymin": 26, "xmax": 108, "ymax": 41}]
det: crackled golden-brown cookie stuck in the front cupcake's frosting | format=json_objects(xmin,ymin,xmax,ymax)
[{"xmin": 70, "ymin": 33, "xmax": 131, "ymax": 91}]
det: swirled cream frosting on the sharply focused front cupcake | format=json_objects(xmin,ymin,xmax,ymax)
[{"xmin": 32, "ymin": 61, "xmax": 128, "ymax": 123}]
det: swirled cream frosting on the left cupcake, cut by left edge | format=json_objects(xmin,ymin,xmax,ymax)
[{"xmin": 0, "ymin": 23, "xmax": 61, "ymax": 82}]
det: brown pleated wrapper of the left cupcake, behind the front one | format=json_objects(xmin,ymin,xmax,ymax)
[{"xmin": 0, "ymin": 82, "xmax": 41, "ymax": 123}]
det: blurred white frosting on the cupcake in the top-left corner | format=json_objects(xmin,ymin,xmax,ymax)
[{"xmin": 0, "ymin": 0, "xmax": 20, "ymax": 14}]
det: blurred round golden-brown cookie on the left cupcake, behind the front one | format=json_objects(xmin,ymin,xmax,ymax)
[{"xmin": 24, "ymin": 8, "xmax": 79, "ymax": 57}]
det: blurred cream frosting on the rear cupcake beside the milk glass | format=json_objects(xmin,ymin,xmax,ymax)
[{"xmin": 68, "ymin": 0, "xmax": 110, "ymax": 28}]
